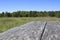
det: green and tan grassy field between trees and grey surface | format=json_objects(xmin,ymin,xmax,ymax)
[{"xmin": 0, "ymin": 17, "xmax": 60, "ymax": 33}]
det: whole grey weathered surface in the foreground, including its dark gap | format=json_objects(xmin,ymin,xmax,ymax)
[{"xmin": 0, "ymin": 21, "xmax": 60, "ymax": 40}]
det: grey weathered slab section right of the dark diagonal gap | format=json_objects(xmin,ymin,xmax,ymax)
[{"xmin": 41, "ymin": 22, "xmax": 60, "ymax": 40}]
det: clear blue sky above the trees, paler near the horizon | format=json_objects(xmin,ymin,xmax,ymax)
[{"xmin": 0, "ymin": 0, "xmax": 60, "ymax": 12}]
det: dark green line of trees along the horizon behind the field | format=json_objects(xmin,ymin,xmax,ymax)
[{"xmin": 0, "ymin": 11, "xmax": 60, "ymax": 18}]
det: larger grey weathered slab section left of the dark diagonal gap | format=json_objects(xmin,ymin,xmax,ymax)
[{"xmin": 0, "ymin": 21, "xmax": 46, "ymax": 40}]
